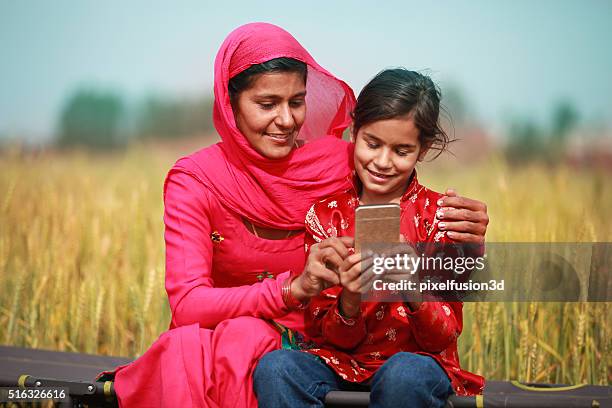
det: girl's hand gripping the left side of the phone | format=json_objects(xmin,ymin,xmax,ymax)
[{"xmin": 338, "ymin": 252, "xmax": 376, "ymax": 318}]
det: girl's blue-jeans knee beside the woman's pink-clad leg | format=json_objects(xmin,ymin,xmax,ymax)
[{"xmin": 253, "ymin": 350, "xmax": 340, "ymax": 408}]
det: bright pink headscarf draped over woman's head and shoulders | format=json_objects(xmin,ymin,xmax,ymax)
[{"xmin": 171, "ymin": 23, "xmax": 355, "ymax": 229}]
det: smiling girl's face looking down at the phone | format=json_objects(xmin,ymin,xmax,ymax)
[{"xmin": 353, "ymin": 115, "xmax": 422, "ymax": 204}]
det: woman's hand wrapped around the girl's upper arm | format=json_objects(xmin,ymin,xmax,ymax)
[{"xmin": 436, "ymin": 188, "xmax": 489, "ymax": 244}]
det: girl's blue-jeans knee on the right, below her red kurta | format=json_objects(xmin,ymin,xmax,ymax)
[{"xmin": 370, "ymin": 353, "xmax": 453, "ymax": 408}]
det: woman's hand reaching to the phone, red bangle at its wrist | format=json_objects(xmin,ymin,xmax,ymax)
[{"xmin": 291, "ymin": 237, "xmax": 354, "ymax": 301}]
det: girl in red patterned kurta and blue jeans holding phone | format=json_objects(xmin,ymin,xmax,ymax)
[{"xmin": 255, "ymin": 69, "xmax": 484, "ymax": 407}]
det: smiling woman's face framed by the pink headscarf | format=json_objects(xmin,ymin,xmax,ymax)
[{"xmin": 232, "ymin": 72, "xmax": 306, "ymax": 159}]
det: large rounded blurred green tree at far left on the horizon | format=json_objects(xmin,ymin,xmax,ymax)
[{"xmin": 57, "ymin": 89, "xmax": 125, "ymax": 148}]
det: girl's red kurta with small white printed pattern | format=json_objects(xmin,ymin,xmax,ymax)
[{"xmin": 304, "ymin": 173, "xmax": 484, "ymax": 395}]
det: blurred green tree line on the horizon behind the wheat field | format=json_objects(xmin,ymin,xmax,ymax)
[{"xmin": 55, "ymin": 87, "xmax": 579, "ymax": 162}]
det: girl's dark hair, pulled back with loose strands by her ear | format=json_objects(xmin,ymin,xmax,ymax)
[{"xmin": 353, "ymin": 68, "xmax": 450, "ymax": 158}]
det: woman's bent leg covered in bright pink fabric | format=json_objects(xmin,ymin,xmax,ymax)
[{"xmin": 115, "ymin": 316, "xmax": 280, "ymax": 408}]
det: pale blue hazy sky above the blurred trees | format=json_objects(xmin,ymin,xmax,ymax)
[{"xmin": 0, "ymin": 0, "xmax": 612, "ymax": 141}]
